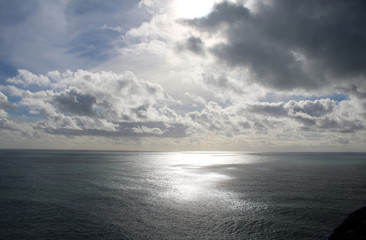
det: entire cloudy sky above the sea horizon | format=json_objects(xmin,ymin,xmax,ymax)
[{"xmin": 0, "ymin": 0, "xmax": 366, "ymax": 152}]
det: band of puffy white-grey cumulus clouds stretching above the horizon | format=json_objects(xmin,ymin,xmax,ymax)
[{"xmin": 0, "ymin": 67, "xmax": 365, "ymax": 150}]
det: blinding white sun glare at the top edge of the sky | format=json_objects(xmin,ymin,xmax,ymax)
[{"xmin": 174, "ymin": 0, "xmax": 215, "ymax": 18}]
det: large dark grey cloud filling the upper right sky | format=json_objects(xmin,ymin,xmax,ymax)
[{"xmin": 187, "ymin": 0, "xmax": 366, "ymax": 89}]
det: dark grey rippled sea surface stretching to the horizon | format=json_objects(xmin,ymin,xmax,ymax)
[{"xmin": 0, "ymin": 150, "xmax": 366, "ymax": 240}]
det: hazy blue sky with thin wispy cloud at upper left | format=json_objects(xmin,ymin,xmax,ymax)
[{"xmin": 0, "ymin": 0, "xmax": 151, "ymax": 81}]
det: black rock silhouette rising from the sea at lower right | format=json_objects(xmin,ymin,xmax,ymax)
[{"xmin": 328, "ymin": 207, "xmax": 366, "ymax": 240}]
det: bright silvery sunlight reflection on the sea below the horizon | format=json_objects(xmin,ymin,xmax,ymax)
[{"xmin": 156, "ymin": 153, "xmax": 254, "ymax": 209}]
